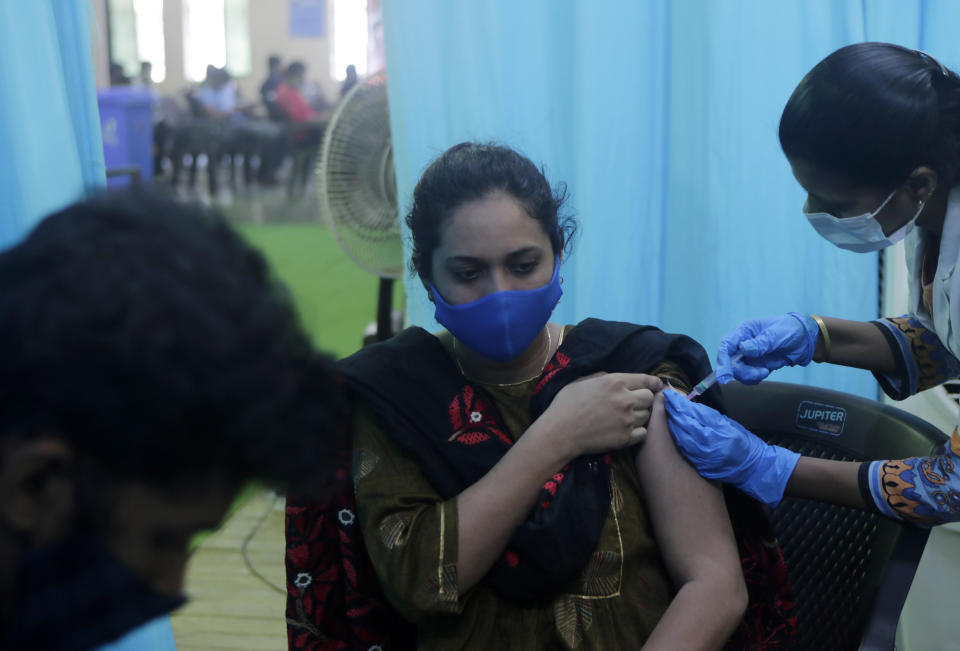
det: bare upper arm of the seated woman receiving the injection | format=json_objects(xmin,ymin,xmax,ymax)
[{"xmin": 636, "ymin": 389, "xmax": 743, "ymax": 589}]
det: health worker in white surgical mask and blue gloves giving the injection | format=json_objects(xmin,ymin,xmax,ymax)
[{"xmin": 665, "ymin": 43, "xmax": 960, "ymax": 526}]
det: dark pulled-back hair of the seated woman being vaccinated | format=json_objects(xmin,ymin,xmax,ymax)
[{"xmin": 406, "ymin": 142, "xmax": 577, "ymax": 280}]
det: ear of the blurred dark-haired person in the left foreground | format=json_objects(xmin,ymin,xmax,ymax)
[{"xmin": 0, "ymin": 437, "xmax": 76, "ymax": 545}]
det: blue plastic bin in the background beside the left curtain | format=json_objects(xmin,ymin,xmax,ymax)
[{"xmin": 97, "ymin": 86, "xmax": 153, "ymax": 188}]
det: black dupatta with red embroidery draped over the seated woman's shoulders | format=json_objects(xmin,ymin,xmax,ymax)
[{"xmin": 339, "ymin": 319, "xmax": 720, "ymax": 601}]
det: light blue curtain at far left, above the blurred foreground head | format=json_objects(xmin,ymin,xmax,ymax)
[{"xmin": 0, "ymin": 0, "xmax": 105, "ymax": 249}]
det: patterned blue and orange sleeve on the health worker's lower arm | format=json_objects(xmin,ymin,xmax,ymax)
[{"xmin": 860, "ymin": 429, "xmax": 960, "ymax": 527}]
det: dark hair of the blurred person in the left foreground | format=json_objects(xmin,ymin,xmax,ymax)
[{"xmin": 0, "ymin": 191, "xmax": 346, "ymax": 486}]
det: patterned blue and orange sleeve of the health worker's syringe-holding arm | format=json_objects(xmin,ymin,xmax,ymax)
[{"xmin": 872, "ymin": 315, "xmax": 960, "ymax": 400}]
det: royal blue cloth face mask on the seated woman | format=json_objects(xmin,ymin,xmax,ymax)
[{"xmin": 430, "ymin": 258, "xmax": 563, "ymax": 362}]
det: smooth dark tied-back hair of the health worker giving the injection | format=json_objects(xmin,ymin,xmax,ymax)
[{"xmin": 780, "ymin": 43, "xmax": 960, "ymax": 190}]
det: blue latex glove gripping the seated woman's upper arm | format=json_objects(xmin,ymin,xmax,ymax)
[{"xmin": 663, "ymin": 389, "xmax": 800, "ymax": 508}]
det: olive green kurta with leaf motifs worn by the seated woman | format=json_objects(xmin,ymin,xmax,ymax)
[{"xmin": 354, "ymin": 338, "xmax": 686, "ymax": 651}]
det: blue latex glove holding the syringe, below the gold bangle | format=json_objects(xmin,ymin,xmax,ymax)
[{"xmin": 717, "ymin": 312, "xmax": 820, "ymax": 384}]
